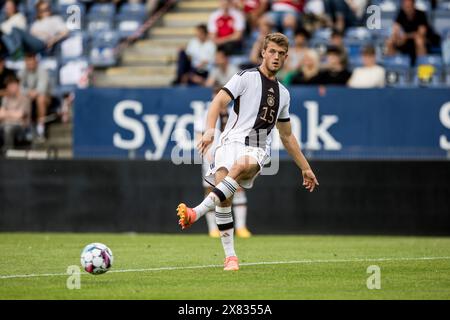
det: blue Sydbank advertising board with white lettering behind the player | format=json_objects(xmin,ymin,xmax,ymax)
[{"xmin": 74, "ymin": 87, "xmax": 450, "ymax": 159}]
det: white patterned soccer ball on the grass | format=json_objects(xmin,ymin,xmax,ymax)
[{"xmin": 81, "ymin": 243, "xmax": 114, "ymax": 274}]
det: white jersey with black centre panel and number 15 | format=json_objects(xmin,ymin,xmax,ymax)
[{"xmin": 219, "ymin": 68, "xmax": 290, "ymax": 154}]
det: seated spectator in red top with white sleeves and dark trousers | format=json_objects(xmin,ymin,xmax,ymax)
[{"xmin": 208, "ymin": 0, "xmax": 245, "ymax": 55}]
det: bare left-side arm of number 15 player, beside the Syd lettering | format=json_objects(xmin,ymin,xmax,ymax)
[{"xmin": 197, "ymin": 90, "xmax": 231, "ymax": 155}]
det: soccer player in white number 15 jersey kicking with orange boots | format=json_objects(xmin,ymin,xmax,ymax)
[{"xmin": 177, "ymin": 33, "xmax": 319, "ymax": 271}]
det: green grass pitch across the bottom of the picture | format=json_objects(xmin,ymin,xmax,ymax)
[{"xmin": 0, "ymin": 232, "xmax": 450, "ymax": 299}]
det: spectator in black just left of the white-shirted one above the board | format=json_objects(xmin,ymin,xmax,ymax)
[{"xmin": 317, "ymin": 46, "xmax": 351, "ymax": 85}]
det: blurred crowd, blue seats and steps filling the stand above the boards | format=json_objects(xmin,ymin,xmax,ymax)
[{"xmin": 0, "ymin": 0, "xmax": 450, "ymax": 156}]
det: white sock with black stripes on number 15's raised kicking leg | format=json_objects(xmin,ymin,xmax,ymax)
[{"xmin": 194, "ymin": 176, "xmax": 239, "ymax": 221}]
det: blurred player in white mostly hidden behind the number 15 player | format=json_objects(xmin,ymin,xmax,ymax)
[{"xmin": 194, "ymin": 86, "xmax": 252, "ymax": 238}]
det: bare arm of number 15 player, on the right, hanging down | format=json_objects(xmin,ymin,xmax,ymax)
[{"xmin": 277, "ymin": 121, "xmax": 319, "ymax": 192}]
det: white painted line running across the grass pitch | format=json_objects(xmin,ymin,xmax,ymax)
[{"xmin": 0, "ymin": 257, "xmax": 450, "ymax": 279}]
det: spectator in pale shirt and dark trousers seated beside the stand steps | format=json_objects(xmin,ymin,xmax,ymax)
[{"xmin": 174, "ymin": 24, "xmax": 216, "ymax": 84}]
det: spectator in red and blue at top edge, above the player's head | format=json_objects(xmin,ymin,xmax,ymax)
[{"xmin": 266, "ymin": 0, "xmax": 305, "ymax": 41}]
